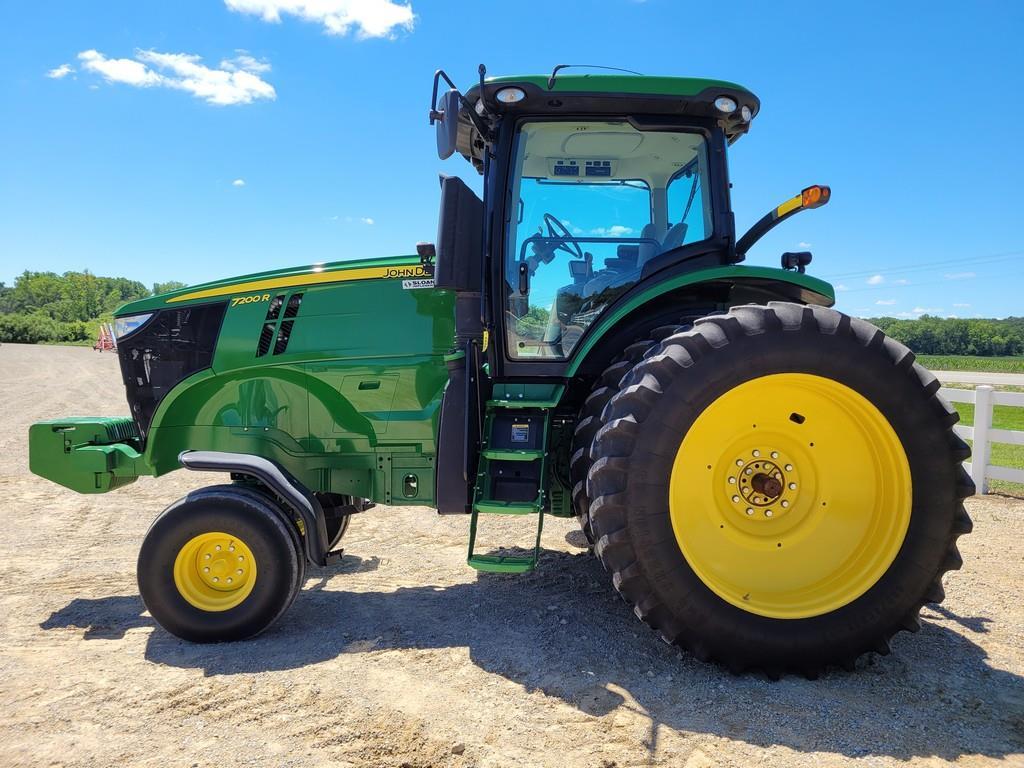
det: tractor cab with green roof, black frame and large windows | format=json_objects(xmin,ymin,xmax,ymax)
[{"xmin": 431, "ymin": 67, "xmax": 759, "ymax": 376}]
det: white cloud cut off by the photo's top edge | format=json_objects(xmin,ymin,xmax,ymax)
[{"xmin": 224, "ymin": 0, "xmax": 416, "ymax": 40}]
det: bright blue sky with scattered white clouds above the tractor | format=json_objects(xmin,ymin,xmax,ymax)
[{"xmin": 0, "ymin": 0, "xmax": 1024, "ymax": 316}]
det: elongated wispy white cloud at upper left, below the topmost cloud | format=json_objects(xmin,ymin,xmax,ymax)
[{"xmin": 78, "ymin": 50, "xmax": 278, "ymax": 105}]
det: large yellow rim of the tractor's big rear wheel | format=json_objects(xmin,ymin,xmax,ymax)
[{"xmin": 669, "ymin": 374, "xmax": 911, "ymax": 618}]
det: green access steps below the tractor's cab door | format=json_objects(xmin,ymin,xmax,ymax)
[{"xmin": 466, "ymin": 384, "xmax": 562, "ymax": 573}]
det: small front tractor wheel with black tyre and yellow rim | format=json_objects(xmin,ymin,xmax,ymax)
[{"xmin": 138, "ymin": 485, "xmax": 305, "ymax": 642}]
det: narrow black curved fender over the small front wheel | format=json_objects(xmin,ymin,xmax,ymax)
[{"xmin": 178, "ymin": 451, "xmax": 340, "ymax": 565}]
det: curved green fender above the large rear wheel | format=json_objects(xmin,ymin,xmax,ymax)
[{"xmin": 565, "ymin": 264, "xmax": 836, "ymax": 377}]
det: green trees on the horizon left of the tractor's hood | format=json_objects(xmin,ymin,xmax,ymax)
[{"xmin": 0, "ymin": 271, "xmax": 185, "ymax": 344}]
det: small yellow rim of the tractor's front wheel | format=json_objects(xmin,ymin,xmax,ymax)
[{"xmin": 174, "ymin": 531, "xmax": 256, "ymax": 611}]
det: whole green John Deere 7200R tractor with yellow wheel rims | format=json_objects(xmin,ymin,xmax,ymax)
[{"xmin": 30, "ymin": 67, "xmax": 974, "ymax": 676}]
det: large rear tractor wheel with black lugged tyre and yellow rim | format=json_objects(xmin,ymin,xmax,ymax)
[{"xmin": 588, "ymin": 303, "xmax": 974, "ymax": 675}]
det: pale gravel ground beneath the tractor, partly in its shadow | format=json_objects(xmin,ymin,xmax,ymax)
[{"xmin": 0, "ymin": 345, "xmax": 1024, "ymax": 768}]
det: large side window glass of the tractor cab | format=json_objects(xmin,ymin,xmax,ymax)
[{"xmin": 505, "ymin": 121, "xmax": 712, "ymax": 358}]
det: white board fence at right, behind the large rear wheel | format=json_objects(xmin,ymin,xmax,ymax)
[{"xmin": 939, "ymin": 384, "xmax": 1024, "ymax": 494}]
